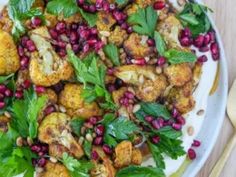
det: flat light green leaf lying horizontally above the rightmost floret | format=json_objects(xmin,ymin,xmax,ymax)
[{"xmin": 164, "ymin": 49, "xmax": 197, "ymax": 64}]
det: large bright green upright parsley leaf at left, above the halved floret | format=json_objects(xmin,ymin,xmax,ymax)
[{"xmin": 11, "ymin": 88, "xmax": 47, "ymax": 139}]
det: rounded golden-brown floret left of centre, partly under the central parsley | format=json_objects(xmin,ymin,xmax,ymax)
[{"xmin": 59, "ymin": 84, "xmax": 101, "ymax": 119}]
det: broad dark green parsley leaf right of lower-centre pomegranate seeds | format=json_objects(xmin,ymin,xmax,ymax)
[{"xmin": 101, "ymin": 114, "xmax": 139, "ymax": 147}]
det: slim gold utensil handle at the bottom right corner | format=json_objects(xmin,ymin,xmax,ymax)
[{"xmin": 209, "ymin": 133, "xmax": 236, "ymax": 177}]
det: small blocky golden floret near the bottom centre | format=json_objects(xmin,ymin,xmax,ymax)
[{"xmin": 114, "ymin": 141, "xmax": 132, "ymax": 168}]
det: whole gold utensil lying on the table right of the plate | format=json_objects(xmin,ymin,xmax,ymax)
[{"xmin": 209, "ymin": 80, "xmax": 236, "ymax": 177}]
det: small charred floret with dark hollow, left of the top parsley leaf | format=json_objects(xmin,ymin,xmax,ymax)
[{"xmin": 96, "ymin": 12, "xmax": 116, "ymax": 31}]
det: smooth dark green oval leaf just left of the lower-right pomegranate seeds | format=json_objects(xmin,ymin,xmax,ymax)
[{"xmin": 141, "ymin": 102, "xmax": 171, "ymax": 120}]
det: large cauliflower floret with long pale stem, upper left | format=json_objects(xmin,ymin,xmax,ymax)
[{"xmin": 29, "ymin": 27, "xmax": 73, "ymax": 87}]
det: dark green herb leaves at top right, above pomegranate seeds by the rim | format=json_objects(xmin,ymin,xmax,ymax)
[{"xmin": 177, "ymin": 2, "xmax": 211, "ymax": 37}]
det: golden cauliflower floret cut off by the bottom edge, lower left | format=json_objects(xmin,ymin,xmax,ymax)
[{"xmin": 38, "ymin": 161, "xmax": 70, "ymax": 177}]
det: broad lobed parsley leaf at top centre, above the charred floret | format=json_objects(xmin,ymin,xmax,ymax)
[{"xmin": 128, "ymin": 6, "xmax": 158, "ymax": 37}]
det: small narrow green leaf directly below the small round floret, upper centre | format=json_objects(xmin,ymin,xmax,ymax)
[{"xmin": 103, "ymin": 44, "xmax": 120, "ymax": 66}]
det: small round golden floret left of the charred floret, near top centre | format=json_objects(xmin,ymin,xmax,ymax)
[{"xmin": 108, "ymin": 26, "xmax": 128, "ymax": 46}]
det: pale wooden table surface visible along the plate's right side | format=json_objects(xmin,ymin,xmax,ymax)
[{"xmin": 197, "ymin": 0, "xmax": 236, "ymax": 177}]
